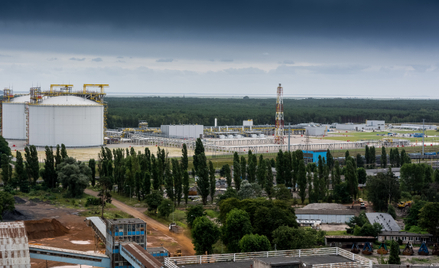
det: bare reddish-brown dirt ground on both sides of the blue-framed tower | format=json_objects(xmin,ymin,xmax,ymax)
[{"xmin": 4, "ymin": 195, "xmax": 194, "ymax": 268}]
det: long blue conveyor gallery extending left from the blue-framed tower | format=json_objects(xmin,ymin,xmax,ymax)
[{"xmin": 29, "ymin": 244, "xmax": 111, "ymax": 268}]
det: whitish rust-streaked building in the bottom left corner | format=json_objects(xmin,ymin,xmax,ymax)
[{"xmin": 0, "ymin": 221, "xmax": 31, "ymax": 268}]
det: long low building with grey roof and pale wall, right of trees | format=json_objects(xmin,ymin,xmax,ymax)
[{"xmin": 296, "ymin": 203, "xmax": 355, "ymax": 223}]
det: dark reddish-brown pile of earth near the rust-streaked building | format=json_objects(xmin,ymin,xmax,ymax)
[{"xmin": 24, "ymin": 219, "xmax": 69, "ymax": 239}]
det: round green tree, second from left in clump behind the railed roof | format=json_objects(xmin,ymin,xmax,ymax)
[{"xmin": 222, "ymin": 208, "xmax": 252, "ymax": 252}]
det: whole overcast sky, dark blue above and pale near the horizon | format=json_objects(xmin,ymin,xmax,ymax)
[{"xmin": 0, "ymin": 0, "xmax": 439, "ymax": 98}]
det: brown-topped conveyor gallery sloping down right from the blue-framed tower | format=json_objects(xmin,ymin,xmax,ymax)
[{"xmin": 120, "ymin": 243, "xmax": 163, "ymax": 268}]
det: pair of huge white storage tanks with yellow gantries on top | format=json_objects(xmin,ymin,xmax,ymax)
[{"xmin": 1, "ymin": 84, "xmax": 108, "ymax": 147}]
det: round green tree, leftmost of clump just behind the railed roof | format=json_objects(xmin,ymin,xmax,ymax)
[{"xmin": 192, "ymin": 216, "xmax": 221, "ymax": 255}]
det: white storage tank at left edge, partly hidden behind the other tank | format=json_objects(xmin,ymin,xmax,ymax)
[{"xmin": 2, "ymin": 95, "xmax": 29, "ymax": 140}]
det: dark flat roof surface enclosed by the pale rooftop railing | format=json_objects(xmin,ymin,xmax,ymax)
[{"xmin": 185, "ymin": 255, "xmax": 353, "ymax": 268}]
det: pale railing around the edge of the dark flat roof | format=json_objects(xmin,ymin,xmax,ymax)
[{"xmin": 165, "ymin": 247, "xmax": 372, "ymax": 268}]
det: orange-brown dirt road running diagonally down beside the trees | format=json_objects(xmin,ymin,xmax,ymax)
[{"xmin": 84, "ymin": 189, "xmax": 195, "ymax": 256}]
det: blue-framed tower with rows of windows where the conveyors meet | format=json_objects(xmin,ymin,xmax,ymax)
[{"xmin": 105, "ymin": 218, "xmax": 146, "ymax": 268}]
